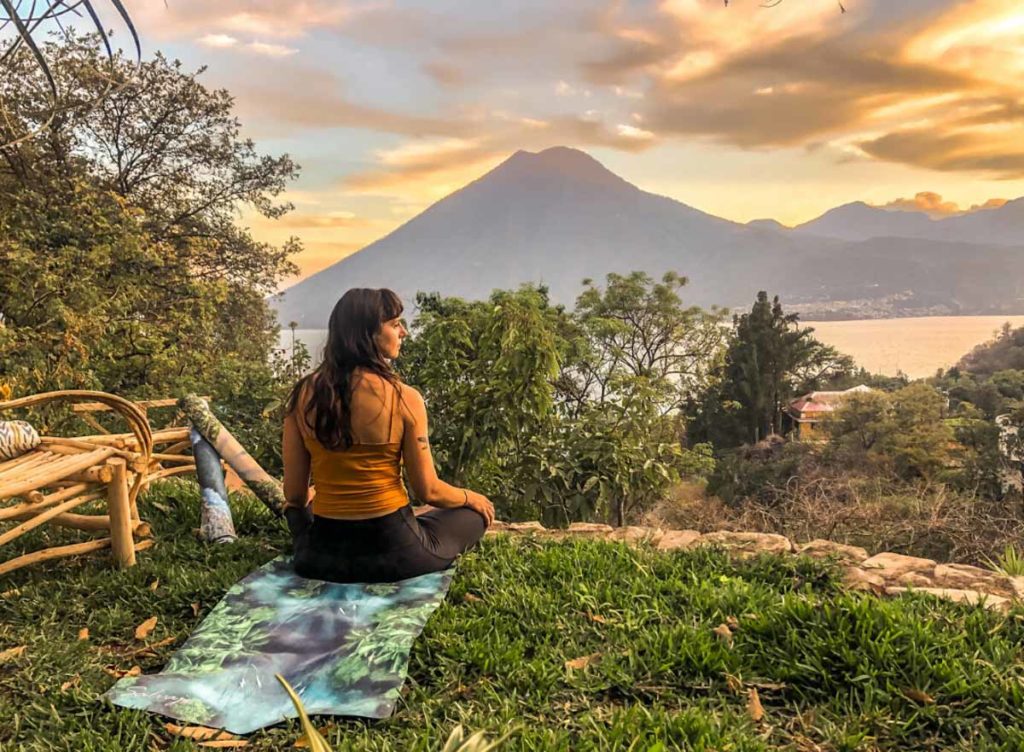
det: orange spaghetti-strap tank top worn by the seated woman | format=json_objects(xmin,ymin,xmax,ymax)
[{"xmin": 302, "ymin": 379, "xmax": 409, "ymax": 518}]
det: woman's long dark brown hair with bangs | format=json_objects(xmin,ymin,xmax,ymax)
[{"xmin": 288, "ymin": 287, "xmax": 403, "ymax": 450}]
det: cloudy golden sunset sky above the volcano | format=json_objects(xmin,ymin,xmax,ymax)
[{"xmin": 108, "ymin": 0, "xmax": 1024, "ymax": 282}]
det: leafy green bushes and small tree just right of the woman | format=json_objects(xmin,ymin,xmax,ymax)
[{"xmin": 398, "ymin": 273, "xmax": 721, "ymax": 525}]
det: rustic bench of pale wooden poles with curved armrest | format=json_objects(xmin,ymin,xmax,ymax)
[{"xmin": 0, "ymin": 391, "xmax": 160, "ymax": 575}]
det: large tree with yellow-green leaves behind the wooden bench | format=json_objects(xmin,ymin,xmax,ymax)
[{"xmin": 0, "ymin": 36, "xmax": 302, "ymax": 467}]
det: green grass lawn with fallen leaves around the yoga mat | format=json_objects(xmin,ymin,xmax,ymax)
[{"xmin": 0, "ymin": 483, "xmax": 1024, "ymax": 752}]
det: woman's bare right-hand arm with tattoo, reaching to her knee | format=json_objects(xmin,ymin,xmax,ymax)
[{"xmin": 401, "ymin": 384, "xmax": 495, "ymax": 525}]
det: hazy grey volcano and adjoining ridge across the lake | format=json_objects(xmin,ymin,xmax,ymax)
[{"xmin": 274, "ymin": 147, "xmax": 1024, "ymax": 329}]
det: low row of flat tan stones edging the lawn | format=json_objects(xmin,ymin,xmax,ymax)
[{"xmin": 487, "ymin": 519, "xmax": 1024, "ymax": 612}]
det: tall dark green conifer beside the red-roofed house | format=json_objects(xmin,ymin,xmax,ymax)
[{"xmin": 694, "ymin": 291, "xmax": 853, "ymax": 449}]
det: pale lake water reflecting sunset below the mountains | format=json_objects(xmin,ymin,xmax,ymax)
[{"xmin": 281, "ymin": 316, "xmax": 1024, "ymax": 378}]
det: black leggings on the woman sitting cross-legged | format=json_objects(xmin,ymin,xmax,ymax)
[{"xmin": 285, "ymin": 504, "xmax": 485, "ymax": 582}]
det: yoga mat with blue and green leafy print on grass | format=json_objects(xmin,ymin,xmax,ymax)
[{"xmin": 104, "ymin": 556, "xmax": 453, "ymax": 734}]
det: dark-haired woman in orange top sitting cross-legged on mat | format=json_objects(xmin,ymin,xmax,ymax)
[{"xmin": 283, "ymin": 289, "xmax": 495, "ymax": 582}]
